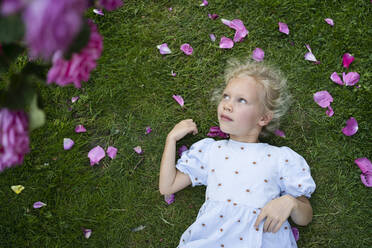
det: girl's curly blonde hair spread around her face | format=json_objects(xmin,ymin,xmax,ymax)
[{"xmin": 212, "ymin": 59, "xmax": 291, "ymax": 137}]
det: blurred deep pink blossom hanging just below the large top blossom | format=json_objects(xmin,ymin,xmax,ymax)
[{"xmin": 47, "ymin": 21, "xmax": 103, "ymax": 88}]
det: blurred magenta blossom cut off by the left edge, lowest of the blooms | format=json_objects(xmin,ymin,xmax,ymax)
[{"xmin": 0, "ymin": 108, "xmax": 30, "ymax": 172}]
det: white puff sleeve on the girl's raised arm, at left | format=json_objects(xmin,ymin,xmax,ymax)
[{"xmin": 176, "ymin": 138, "xmax": 215, "ymax": 187}]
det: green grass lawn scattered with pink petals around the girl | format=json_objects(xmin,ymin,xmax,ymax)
[{"xmin": 0, "ymin": 0, "xmax": 372, "ymax": 248}]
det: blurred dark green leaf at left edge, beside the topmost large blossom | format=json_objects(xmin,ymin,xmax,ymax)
[{"xmin": 0, "ymin": 15, "xmax": 25, "ymax": 44}]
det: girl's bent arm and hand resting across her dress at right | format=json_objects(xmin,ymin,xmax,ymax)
[{"xmin": 255, "ymin": 195, "xmax": 313, "ymax": 233}]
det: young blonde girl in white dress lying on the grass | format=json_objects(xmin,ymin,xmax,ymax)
[{"xmin": 159, "ymin": 61, "xmax": 315, "ymax": 248}]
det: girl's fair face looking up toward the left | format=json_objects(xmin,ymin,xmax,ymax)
[{"xmin": 217, "ymin": 76, "xmax": 271, "ymax": 142}]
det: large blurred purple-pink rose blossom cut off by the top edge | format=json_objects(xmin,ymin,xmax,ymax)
[{"xmin": 23, "ymin": 0, "xmax": 88, "ymax": 60}]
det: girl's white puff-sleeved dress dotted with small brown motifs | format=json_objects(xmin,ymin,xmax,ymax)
[{"xmin": 176, "ymin": 138, "xmax": 315, "ymax": 248}]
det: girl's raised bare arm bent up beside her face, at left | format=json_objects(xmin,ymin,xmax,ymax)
[{"xmin": 159, "ymin": 119, "xmax": 198, "ymax": 195}]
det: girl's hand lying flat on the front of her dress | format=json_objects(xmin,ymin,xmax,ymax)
[{"xmin": 254, "ymin": 195, "xmax": 296, "ymax": 233}]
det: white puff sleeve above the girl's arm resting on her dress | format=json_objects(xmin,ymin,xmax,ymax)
[{"xmin": 279, "ymin": 147, "xmax": 316, "ymax": 198}]
